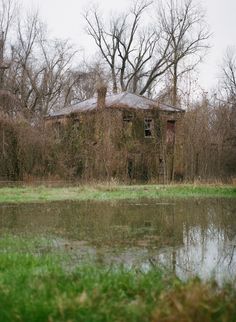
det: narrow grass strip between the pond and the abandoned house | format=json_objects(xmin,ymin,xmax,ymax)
[{"xmin": 0, "ymin": 184, "xmax": 236, "ymax": 203}]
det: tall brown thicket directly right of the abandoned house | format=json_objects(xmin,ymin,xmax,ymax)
[{"xmin": 184, "ymin": 99, "xmax": 236, "ymax": 181}]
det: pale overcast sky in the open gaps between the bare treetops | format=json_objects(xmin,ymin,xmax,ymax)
[{"xmin": 21, "ymin": 0, "xmax": 236, "ymax": 91}]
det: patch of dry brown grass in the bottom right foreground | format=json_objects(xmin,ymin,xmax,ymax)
[{"xmin": 152, "ymin": 280, "xmax": 236, "ymax": 322}]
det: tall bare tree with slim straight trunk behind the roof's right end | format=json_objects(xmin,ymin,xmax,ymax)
[{"xmin": 158, "ymin": 0, "xmax": 210, "ymax": 106}]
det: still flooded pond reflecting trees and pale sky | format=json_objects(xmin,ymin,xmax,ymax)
[{"xmin": 0, "ymin": 199, "xmax": 236, "ymax": 281}]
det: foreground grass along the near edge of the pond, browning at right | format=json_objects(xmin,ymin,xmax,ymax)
[{"xmin": 0, "ymin": 236, "xmax": 236, "ymax": 322}]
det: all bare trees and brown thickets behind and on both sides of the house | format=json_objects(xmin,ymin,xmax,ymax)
[{"xmin": 0, "ymin": 0, "xmax": 236, "ymax": 180}]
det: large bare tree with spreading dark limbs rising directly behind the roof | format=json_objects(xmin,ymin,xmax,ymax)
[{"xmin": 85, "ymin": 0, "xmax": 172, "ymax": 94}]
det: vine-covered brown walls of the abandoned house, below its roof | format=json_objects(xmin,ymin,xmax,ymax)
[{"xmin": 47, "ymin": 106, "xmax": 182, "ymax": 182}]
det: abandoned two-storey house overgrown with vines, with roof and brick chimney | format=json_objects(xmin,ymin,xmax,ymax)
[{"xmin": 46, "ymin": 86, "xmax": 184, "ymax": 182}]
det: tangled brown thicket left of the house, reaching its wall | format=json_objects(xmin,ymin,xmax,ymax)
[{"xmin": 0, "ymin": 115, "xmax": 85, "ymax": 181}]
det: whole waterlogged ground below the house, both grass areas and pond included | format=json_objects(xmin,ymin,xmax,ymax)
[{"xmin": 0, "ymin": 185, "xmax": 236, "ymax": 322}]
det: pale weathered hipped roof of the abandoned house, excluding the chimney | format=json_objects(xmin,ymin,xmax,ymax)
[{"xmin": 49, "ymin": 92, "xmax": 183, "ymax": 117}]
